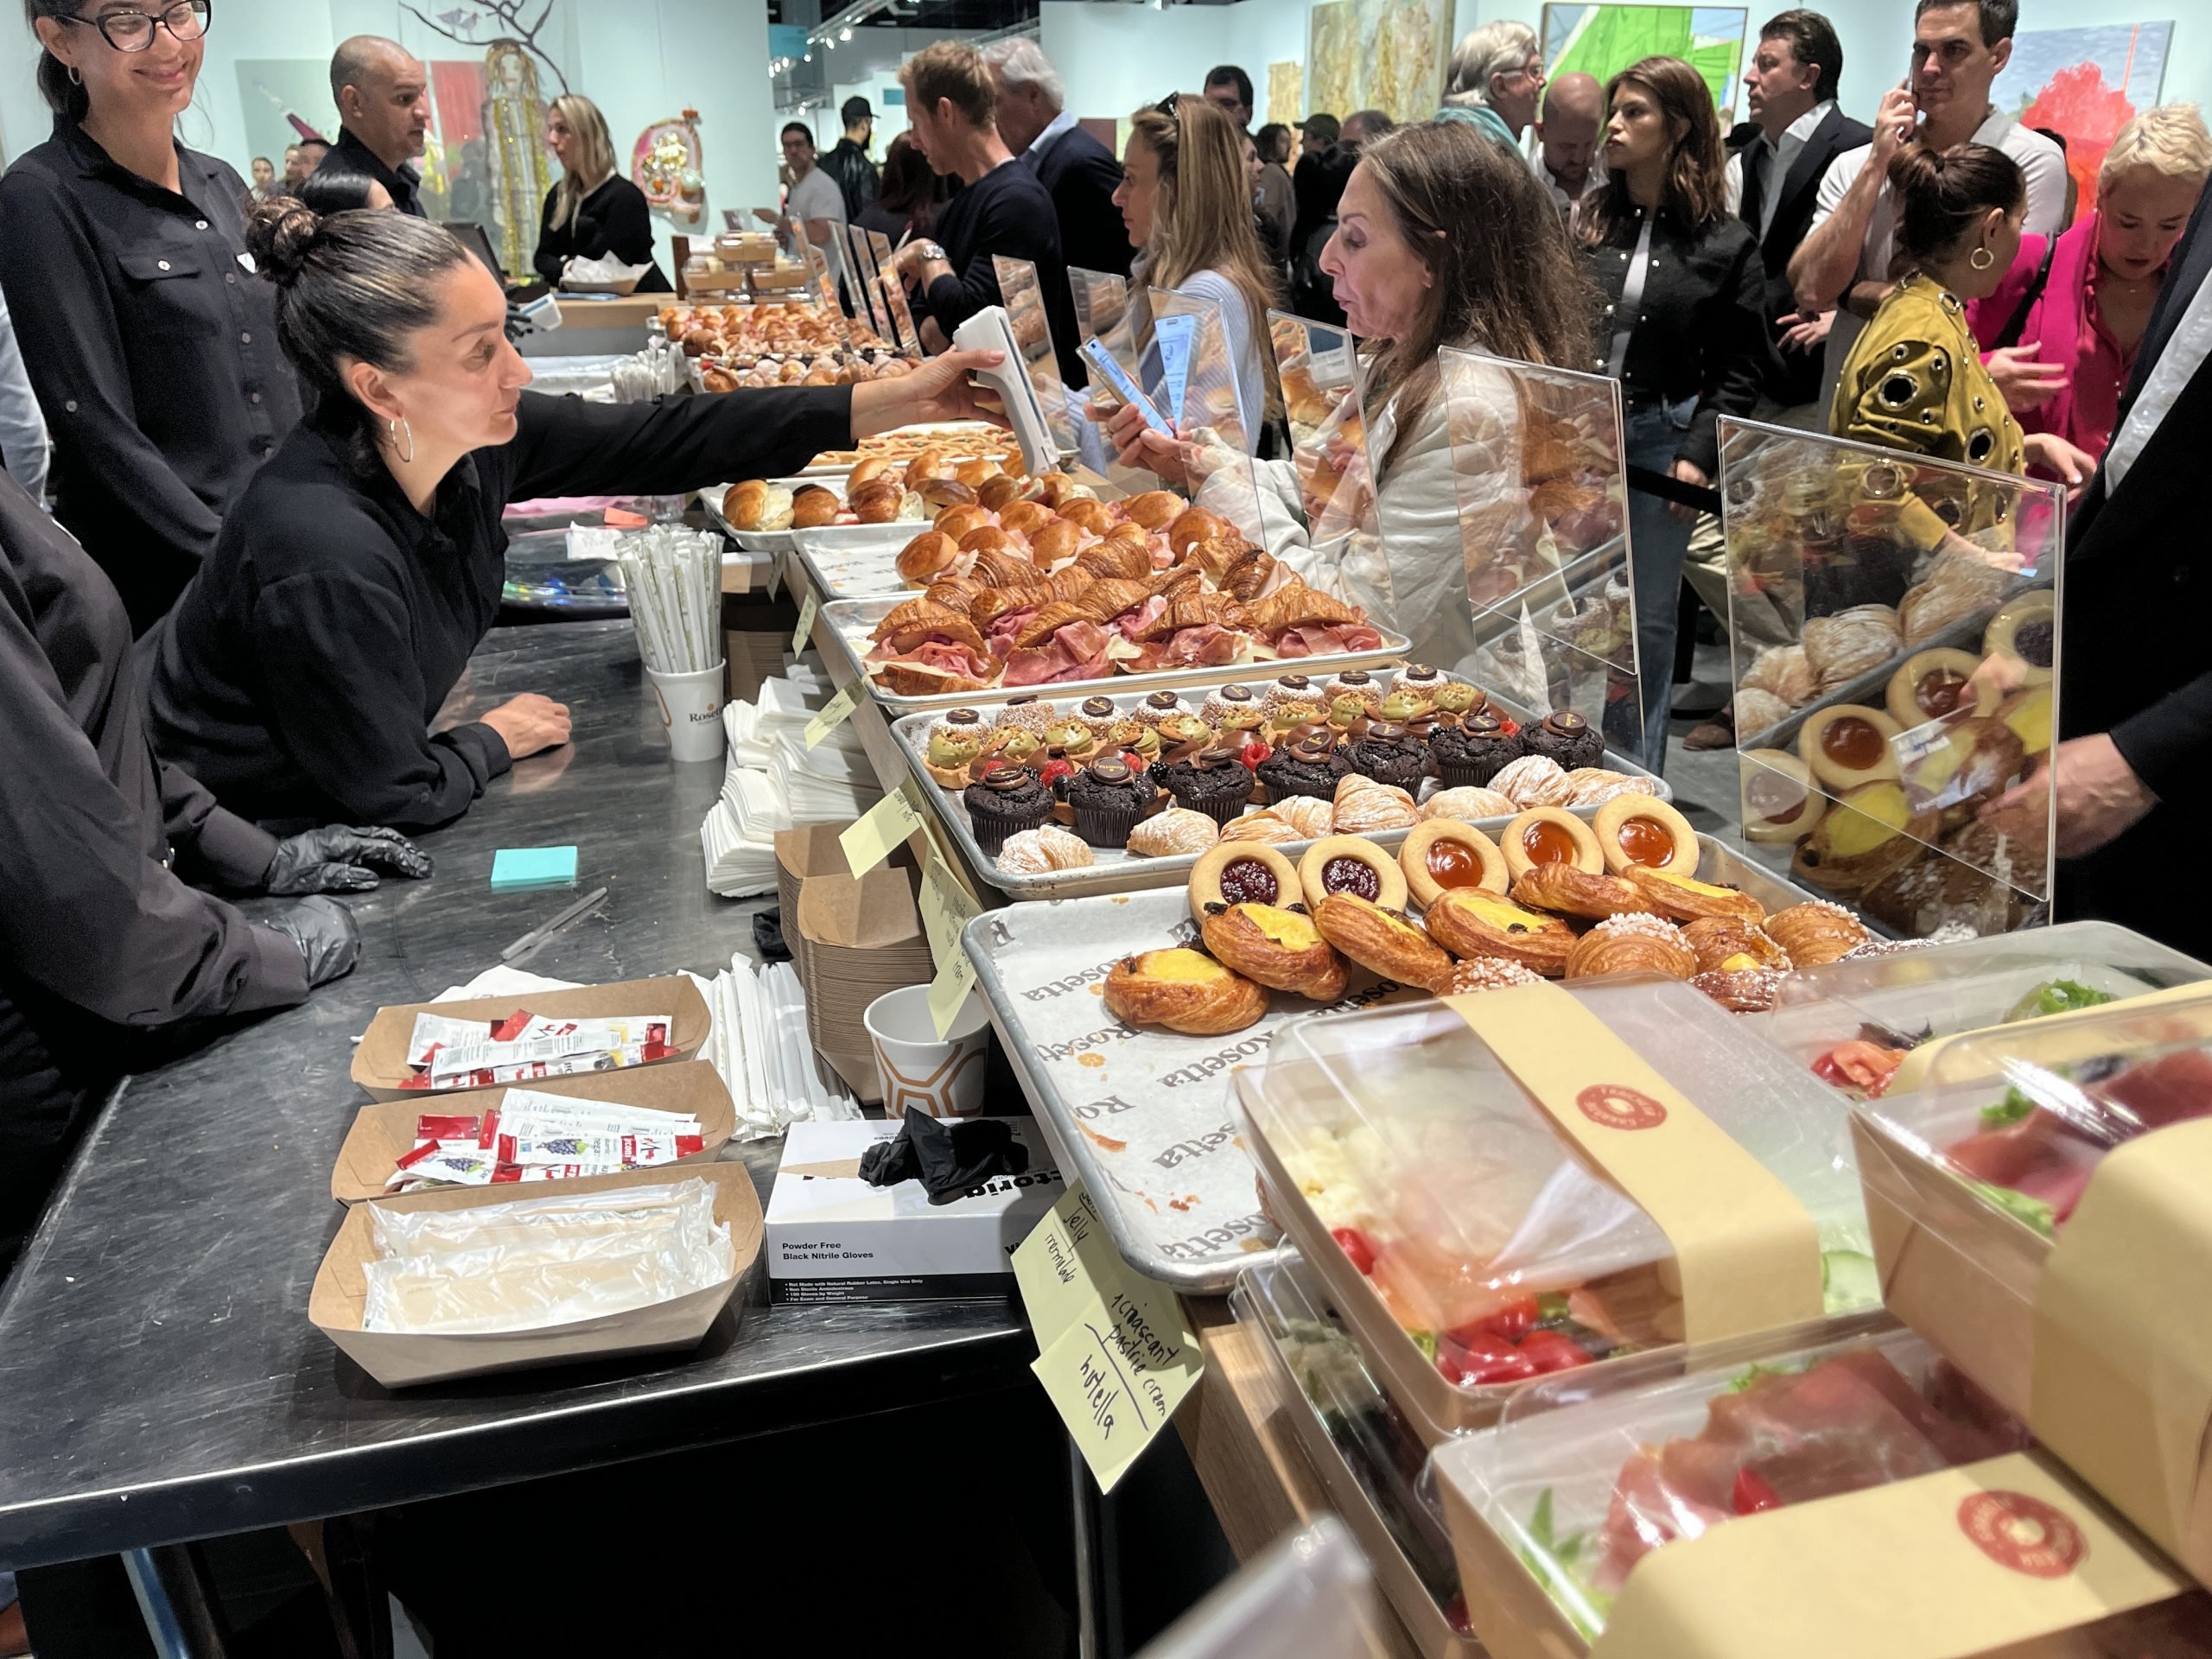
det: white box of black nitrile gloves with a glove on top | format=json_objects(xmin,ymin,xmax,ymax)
[{"xmin": 763, "ymin": 1119, "xmax": 1064, "ymax": 1303}]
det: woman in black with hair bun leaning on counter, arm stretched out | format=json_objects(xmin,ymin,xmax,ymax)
[{"xmin": 142, "ymin": 201, "xmax": 1000, "ymax": 827}]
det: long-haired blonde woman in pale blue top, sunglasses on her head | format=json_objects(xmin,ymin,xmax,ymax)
[{"xmin": 1113, "ymin": 93, "xmax": 1281, "ymax": 454}]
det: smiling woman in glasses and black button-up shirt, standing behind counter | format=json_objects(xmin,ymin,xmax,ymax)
[{"xmin": 0, "ymin": 0, "xmax": 299, "ymax": 632}]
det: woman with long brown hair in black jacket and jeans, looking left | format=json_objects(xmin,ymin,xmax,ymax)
[{"xmin": 1575, "ymin": 58, "xmax": 1767, "ymax": 772}]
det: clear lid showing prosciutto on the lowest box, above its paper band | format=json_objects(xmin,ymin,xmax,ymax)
[{"xmin": 1429, "ymin": 1316, "xmax": 2029, "ymax": 1655}]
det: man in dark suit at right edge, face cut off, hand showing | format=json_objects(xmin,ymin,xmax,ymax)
[{"xmin": 1991, "ymin": 179, "xmax": 2212, "ymax": 956}]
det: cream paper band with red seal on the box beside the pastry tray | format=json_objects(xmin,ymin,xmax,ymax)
[{"xmin": 1445, "ymin": 984, "xmax": 1821, "ymax": 1343}]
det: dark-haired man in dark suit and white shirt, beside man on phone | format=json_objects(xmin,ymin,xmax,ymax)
[{"xmin": 1727, "ymin": 11, "xmax": 1872, "ymax": 410}]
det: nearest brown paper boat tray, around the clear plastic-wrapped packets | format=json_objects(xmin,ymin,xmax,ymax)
[{"xmin": 308, "ymin": 1164, "xmax": 761, "ymax": 1389}]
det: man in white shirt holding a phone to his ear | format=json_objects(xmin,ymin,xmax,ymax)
[{"xmin": 1789, "ymin": 0, "xmax": 2066, "ymax": 410}]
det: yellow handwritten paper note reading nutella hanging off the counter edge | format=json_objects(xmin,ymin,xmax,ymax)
[{"xmin": 1013, "ymin": 1181, "xmax": 1204, "ymax": 1493}]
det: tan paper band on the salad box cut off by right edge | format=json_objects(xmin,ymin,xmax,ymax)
[{"xmin": 2029, "ymin": 1117, "xmax": 2212, "ymax": 1580}]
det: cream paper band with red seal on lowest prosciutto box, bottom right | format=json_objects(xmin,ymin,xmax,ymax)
[{"xmin": 1583, "ymin": 1451, "xmax": 2190, "ymax": 1659}]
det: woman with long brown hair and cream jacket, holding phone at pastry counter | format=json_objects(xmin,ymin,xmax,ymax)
[{"xmin": 1113, "ymin": 122, "xmax": 1591, "ymax": 668}]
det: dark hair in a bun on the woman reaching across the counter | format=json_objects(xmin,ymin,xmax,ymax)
[{"xmin": 245, "ymin": 197, "xmax": 471, "ymax": 465}]
